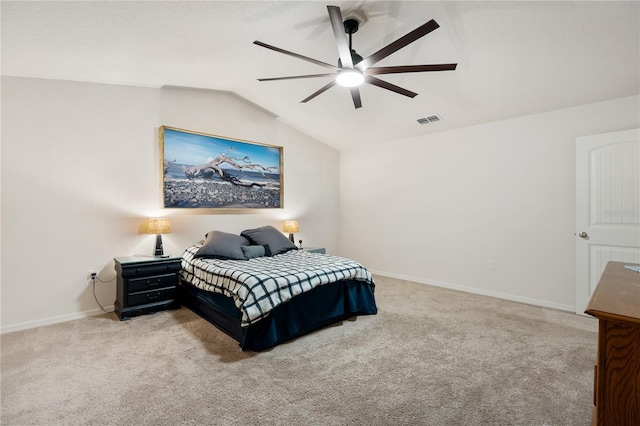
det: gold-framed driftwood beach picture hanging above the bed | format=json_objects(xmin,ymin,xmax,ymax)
[{"xmin": 160, "ymin": 126, "xmax": 283, "ymax": 209}]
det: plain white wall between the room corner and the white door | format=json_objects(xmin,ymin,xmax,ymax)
[{"xmin": 340, "ymin": 96, "xmax": 640, "ymax": 310}]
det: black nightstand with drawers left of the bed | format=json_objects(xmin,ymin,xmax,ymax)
[{"xmin": 113, "ymin": 256, "xmax": 182, "ymax": 321}]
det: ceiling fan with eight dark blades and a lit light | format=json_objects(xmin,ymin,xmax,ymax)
[{"xmin": 253, "ymin": 6, "xmax": 458, "ymax": 108}]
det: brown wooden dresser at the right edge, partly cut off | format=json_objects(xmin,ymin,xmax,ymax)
[{"xmin": 585, "ymin": 262, "xmax": 640, "ymax": 426}]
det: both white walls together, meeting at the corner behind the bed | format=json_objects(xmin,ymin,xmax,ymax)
[{"xmin": 0, "ymin": 77, "xmax": 640, "ymax": 331}]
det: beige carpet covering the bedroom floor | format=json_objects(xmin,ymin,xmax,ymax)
[{"xmin": 0, "ymin": 277, "xmax": 597, "ymax": 426}]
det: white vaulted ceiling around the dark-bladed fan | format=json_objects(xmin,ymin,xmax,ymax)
[{"xmin": 1, "ymin": 1, "xmax": 640, "ymax": 149}]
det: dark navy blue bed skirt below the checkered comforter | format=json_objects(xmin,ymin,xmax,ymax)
[{"xmin": 179, "ymin": 280, "xmax": 378, "ymax": 351}]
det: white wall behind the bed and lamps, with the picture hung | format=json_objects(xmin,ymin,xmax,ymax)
[{"xmin": 1, "ymin": 77, "xmax": 339, "ymax": 332}]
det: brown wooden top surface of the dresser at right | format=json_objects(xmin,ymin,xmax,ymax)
[{"xmin": 585, "ymin": 262, "xmax": 640, "ymax": 325}]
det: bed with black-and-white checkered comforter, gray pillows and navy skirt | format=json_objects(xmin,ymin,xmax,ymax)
[{"xmin": 179, "ymin": 226, "xmax": 377, "ymax": 351}]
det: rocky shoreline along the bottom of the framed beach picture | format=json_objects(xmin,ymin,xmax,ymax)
[{"xmin": 164, "ymin": 179, "xmax": 280, "ymax": 208}]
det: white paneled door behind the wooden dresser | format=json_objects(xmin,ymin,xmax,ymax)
[{"xmin": 576, "ymin": 129, "xmax": 640, "ymax": 314}]
